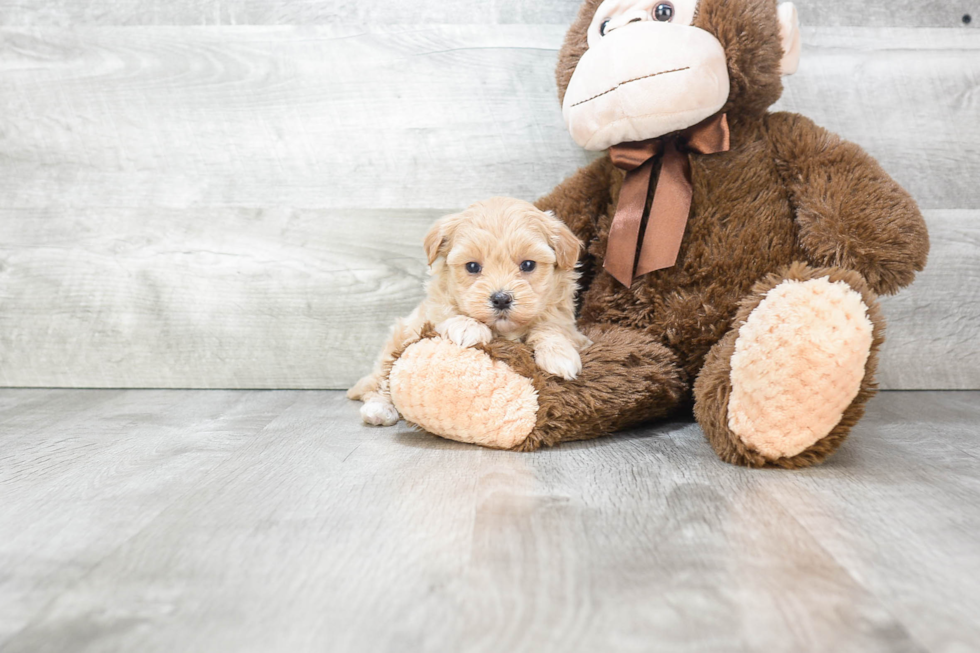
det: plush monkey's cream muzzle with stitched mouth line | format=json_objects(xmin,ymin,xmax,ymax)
[{"xmin": 562, "ymin": 21, "xmax": 730, "ymax": 151}]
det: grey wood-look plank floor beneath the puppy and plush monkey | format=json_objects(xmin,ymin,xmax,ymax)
[{"xmin": 0, "ymin": 390, "xmax": 980, "ymax": 653}]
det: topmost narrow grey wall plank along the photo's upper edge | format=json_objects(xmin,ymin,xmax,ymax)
[{"xmin": 0, "ymin": 0, "xmax": 980, "ymax": 28}]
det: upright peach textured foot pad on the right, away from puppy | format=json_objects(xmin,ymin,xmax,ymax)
[{"xmin": 728, "ymin": 278, "xmax": 874, "ymax": 459}]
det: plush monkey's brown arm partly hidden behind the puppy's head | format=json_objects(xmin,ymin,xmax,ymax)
[{"xmin": 535, "ymin": 156, "xmax": 612, "ymax": 249}]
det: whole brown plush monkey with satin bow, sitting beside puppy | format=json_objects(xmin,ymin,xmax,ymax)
[{"xmin": 374, "ymin": 0, "xmax": 929, "ymax": 468}]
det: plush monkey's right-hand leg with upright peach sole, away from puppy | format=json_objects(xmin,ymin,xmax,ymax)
[{"xmin": 694, "ymin": 263, "xmax": 884, "ymax": 468}]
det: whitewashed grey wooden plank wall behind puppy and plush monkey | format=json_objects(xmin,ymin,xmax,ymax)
[{"xmin": 0, "ymin": 0, "xmax": 980, "ymax": 389}]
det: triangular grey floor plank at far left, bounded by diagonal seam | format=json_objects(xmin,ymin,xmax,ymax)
[{"xmin": 0, "ymin": 391, "xmax": 297, "ymax": 650}]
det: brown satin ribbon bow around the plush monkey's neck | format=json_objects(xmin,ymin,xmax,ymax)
[{"xmin": 604, "ymin": 114, "xmax": 730, "ymax": 288}]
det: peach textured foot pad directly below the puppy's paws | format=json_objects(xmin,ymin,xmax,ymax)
[{"xmin": 390, "ymin": 338, "xmax": 538, "ymax": 449}]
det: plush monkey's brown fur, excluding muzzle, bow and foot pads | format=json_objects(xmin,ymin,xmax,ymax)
[{"xmin": 388, "ymin": 0, "xmax": 929, "ymax": 468}]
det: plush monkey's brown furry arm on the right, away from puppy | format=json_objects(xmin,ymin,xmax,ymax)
[{"xmin": 767, "ymin": 113, "xmax": 929, "ymax": 295}]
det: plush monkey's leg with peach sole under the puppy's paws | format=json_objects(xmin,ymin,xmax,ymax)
[{"xmin": 390, "ymin": 326, "xmax": 690, "ymax": 451}]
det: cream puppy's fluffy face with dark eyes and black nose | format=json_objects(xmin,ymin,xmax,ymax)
[{"xmin": 425, "ymin": 198, "xmax": 580, "ymax": 335}]
